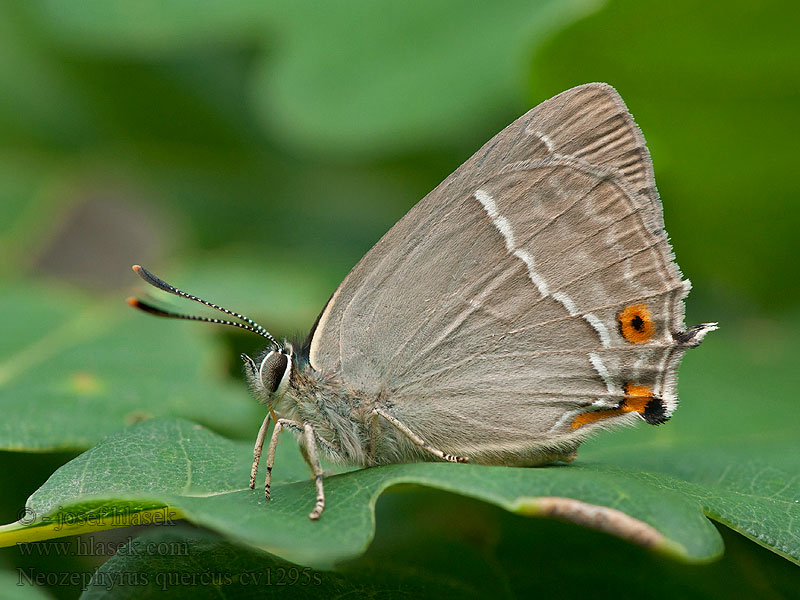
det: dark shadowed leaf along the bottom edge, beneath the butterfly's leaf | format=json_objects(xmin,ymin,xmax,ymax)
[{"xmin": 76, "ymin": 502, "xmax": 797, "ymax": 599}]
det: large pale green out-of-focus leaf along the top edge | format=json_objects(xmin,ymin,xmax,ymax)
[{"xmin": 21, "ymin": 0, "xmax": 599, "ymax": 157}]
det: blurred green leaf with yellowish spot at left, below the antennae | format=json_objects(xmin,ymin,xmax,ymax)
[{"xmin": 0, "ymin": 284, "xmax": 263, "ymax": 451}]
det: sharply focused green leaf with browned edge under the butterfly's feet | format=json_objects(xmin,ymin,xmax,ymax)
[{"xmin": 4, "ymin": 419, "xmax": 722, "ymax": 567}]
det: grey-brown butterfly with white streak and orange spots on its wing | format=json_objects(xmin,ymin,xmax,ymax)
[{"xmin": 129, "ymin": 83, "xmax": 716, "ymax": 519}]
